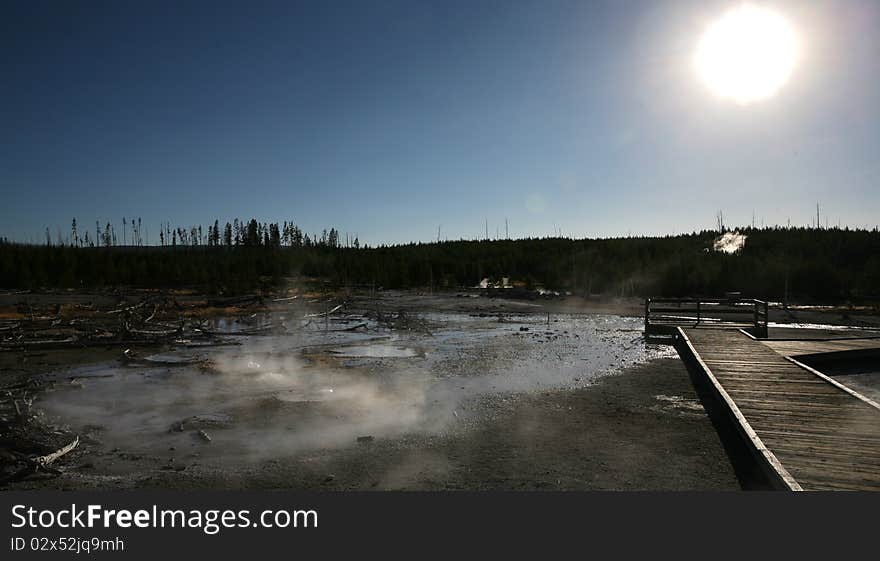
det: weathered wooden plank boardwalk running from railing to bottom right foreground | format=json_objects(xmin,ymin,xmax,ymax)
[{"xmin": 676, "ymin": 328, "xmax": 880, "ymax": 491}]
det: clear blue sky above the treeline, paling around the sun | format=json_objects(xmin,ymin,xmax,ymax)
[{"xmin": 0, "ymin": 0, "xmax": 880, "ymax": 244}]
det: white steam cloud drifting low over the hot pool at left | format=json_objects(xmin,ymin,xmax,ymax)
[{"xmin": 42, "ymin": 332, "xmax": 451, "ymax": 460}]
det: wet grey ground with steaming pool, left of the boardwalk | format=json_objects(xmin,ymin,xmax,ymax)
[{"xmin": 5, "ymin": 293, "xmax": 872, "ymax": 490}]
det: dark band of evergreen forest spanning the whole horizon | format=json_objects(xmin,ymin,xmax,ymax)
[{"xmin": 0, "ymin": 220, "xmax": 880, "ymax": 302}]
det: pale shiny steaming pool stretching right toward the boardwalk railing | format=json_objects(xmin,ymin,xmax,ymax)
[{"xmin": 41, "ymin": 314, "xmax": 672, "ymax": 464}]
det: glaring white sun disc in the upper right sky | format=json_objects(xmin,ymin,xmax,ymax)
[{"xmin": 694, "ymin": 4, "xmax": 798, "ymax": 104}]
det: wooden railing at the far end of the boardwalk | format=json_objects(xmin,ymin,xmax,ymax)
[{"xmin": 645, "ymin": 297, "xmax": 767, "ymax": 337}]
